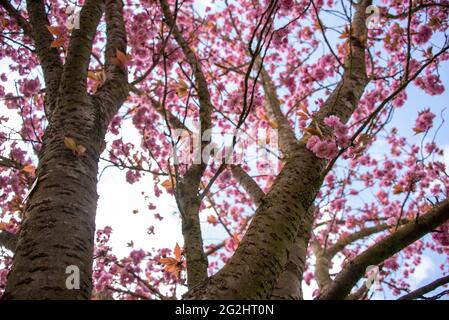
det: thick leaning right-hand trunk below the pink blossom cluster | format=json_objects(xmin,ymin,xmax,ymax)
[{"xmin": 184, "ymin": 146, "xmax": 324, "ymax": 299}]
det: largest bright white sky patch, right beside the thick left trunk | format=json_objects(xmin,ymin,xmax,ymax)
[{"xmin": 96, "ymin": 168, "xmax": 183, "ymax": 256}]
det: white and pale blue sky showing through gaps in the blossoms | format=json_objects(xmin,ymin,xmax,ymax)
[{"xmin": 0, "ymin": 0, "xmax": 449, "ymax": 299}]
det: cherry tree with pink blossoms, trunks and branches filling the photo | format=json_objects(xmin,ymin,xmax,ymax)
[{"xmin": 0, "ymin": 0, "xmax": 449, "ymax": 299}]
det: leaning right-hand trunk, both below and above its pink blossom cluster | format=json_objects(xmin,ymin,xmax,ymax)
[{"xmin": 184, "ymin": 1, "xmax": 371, "ymax": 299}]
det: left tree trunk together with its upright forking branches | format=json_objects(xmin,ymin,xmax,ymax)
[{"xmin": 3, "ymin": 0, "xmax": 127, "ymax": 299}]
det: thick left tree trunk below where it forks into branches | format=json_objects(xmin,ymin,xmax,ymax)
[{"xmin": 3, "ymin": 100, "xmax": 106, "ymax": 299}]
